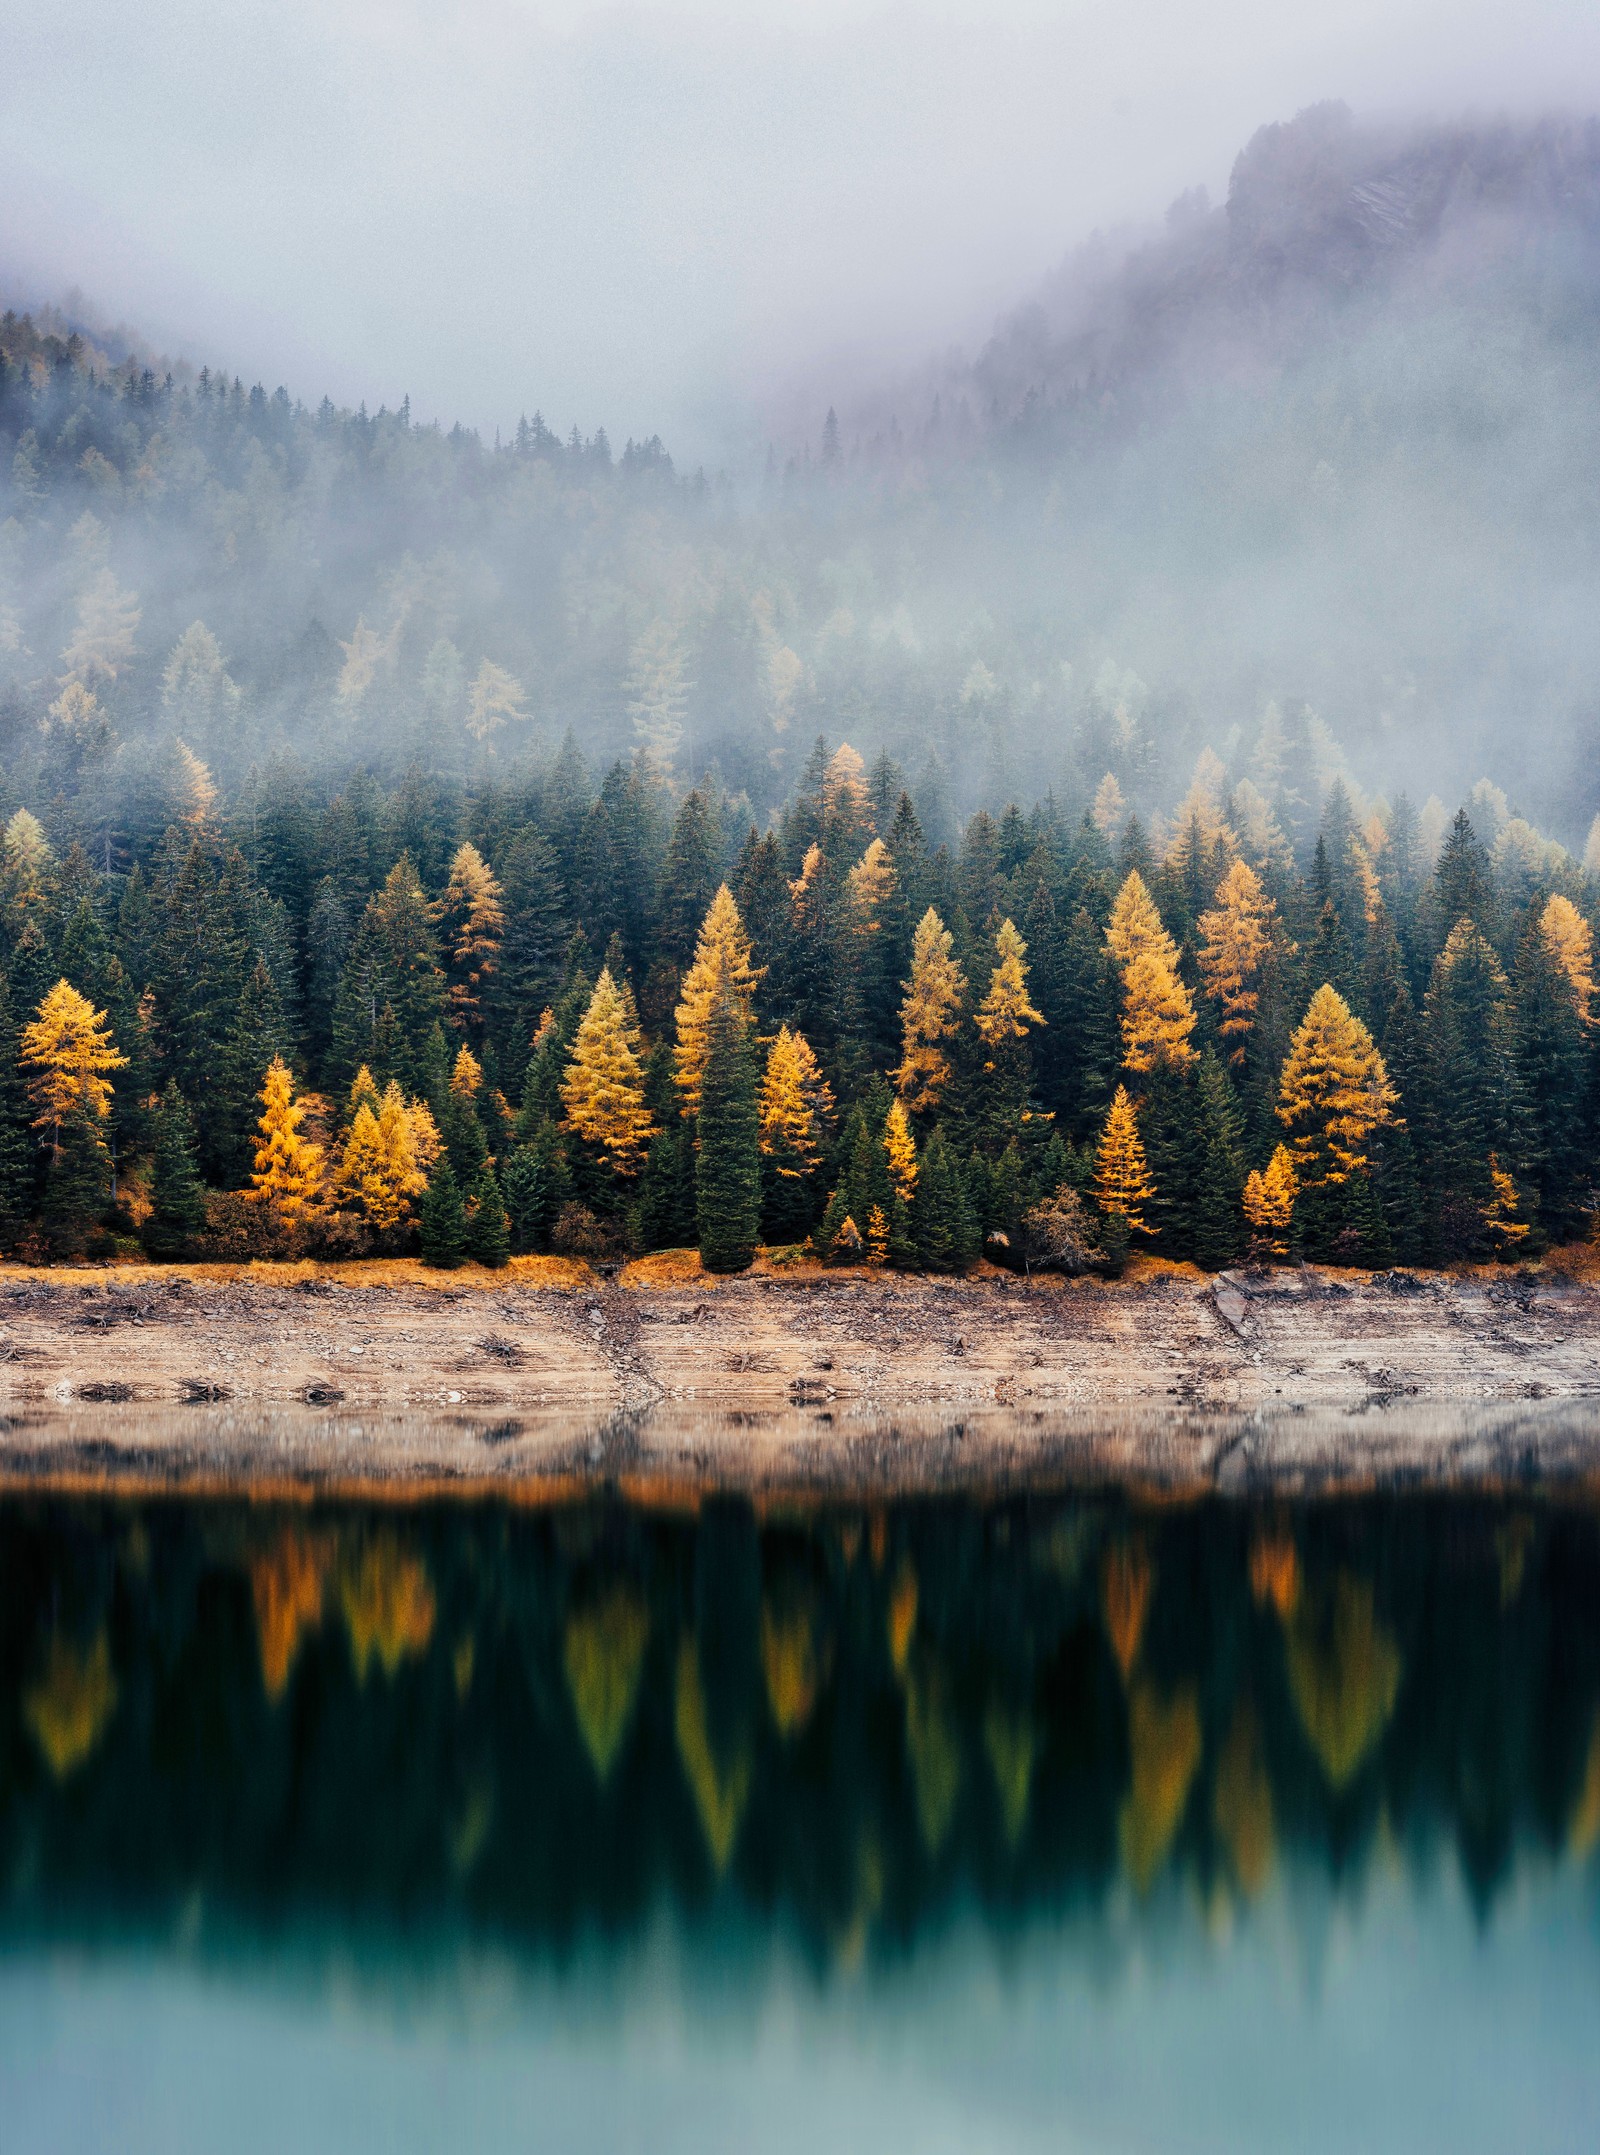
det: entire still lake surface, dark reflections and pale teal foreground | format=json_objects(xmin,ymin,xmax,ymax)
[{"xmin": 0, "ymin": 1430, "xmax": 1600, "ymax": 2155}]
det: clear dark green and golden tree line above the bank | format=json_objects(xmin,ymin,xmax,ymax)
[{"xmin": 0, "ymin": 739, "xmax": 1600, "ymax": 1271}]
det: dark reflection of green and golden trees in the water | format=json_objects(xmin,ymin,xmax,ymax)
[{"xmin": 0, "ymin": 1491, "xmax": 1600, "ymax": 1974}]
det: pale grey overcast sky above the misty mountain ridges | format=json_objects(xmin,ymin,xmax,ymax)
[{"xmin": 0, "ymin": 0, "xmax": 1600, "ymax": 457}]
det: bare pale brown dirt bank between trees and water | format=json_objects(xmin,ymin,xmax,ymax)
[{"xmin": 0, "ymin": 1254, "xmax": 1600, "ymax": 1496}]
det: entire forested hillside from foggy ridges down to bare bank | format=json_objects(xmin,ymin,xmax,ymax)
[{"xmin": 0, "ymin": 112, "xmax": 1600, "ymax": 1269}]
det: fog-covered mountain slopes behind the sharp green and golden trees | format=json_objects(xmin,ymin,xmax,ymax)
[{"xmin": 0, "ymin": 108, "xmax": 1600, "ymax": 843}]
